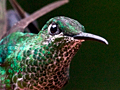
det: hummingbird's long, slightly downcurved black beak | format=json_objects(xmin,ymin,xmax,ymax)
[{"xmin": 73, "ymin": 32, "xmax": 108, "ymax": 45}]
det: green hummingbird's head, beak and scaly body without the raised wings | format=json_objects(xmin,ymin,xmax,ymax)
[{"xmin": 0, "ymin": 16, "xmax": 108, "ymax": 90}]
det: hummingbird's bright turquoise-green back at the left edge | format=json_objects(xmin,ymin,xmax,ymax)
[{"xmin": 0, "ymin": 32, "xmax": 34, "ymax": 90}]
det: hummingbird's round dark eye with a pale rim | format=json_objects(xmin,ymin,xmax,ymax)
[{"xmin": 48, "ymin": 23, "xmax": 60, "ymax": 35}]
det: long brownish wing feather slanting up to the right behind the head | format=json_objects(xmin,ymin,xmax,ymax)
[{"xmin": 4, "ymin": 0, "xmax": 69, "ymax": 36}]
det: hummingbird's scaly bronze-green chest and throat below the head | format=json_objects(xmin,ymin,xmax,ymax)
[{"xmin": 13, "ymin": 40, "xmax": 80, "ymax": 90}]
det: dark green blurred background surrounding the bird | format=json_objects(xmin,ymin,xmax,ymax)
[{"xmin": 7, "ymin": 0, "xmax": 120, "ymax": 90}]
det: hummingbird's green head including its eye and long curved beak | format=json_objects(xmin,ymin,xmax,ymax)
[{"xmin": 41, "ymin": 16, "xmax": 108, "ymax": 45}]
